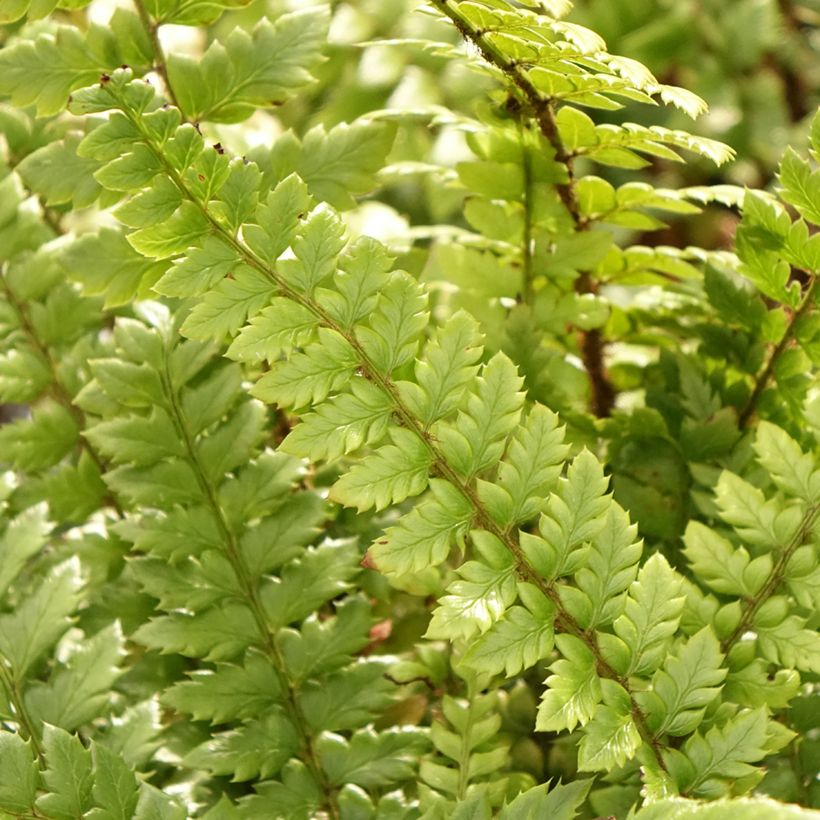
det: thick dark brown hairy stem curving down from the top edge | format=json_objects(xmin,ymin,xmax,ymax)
[{"xmin": 431, "ymin": 0, "xmax": 616, "ymax": 418}]
